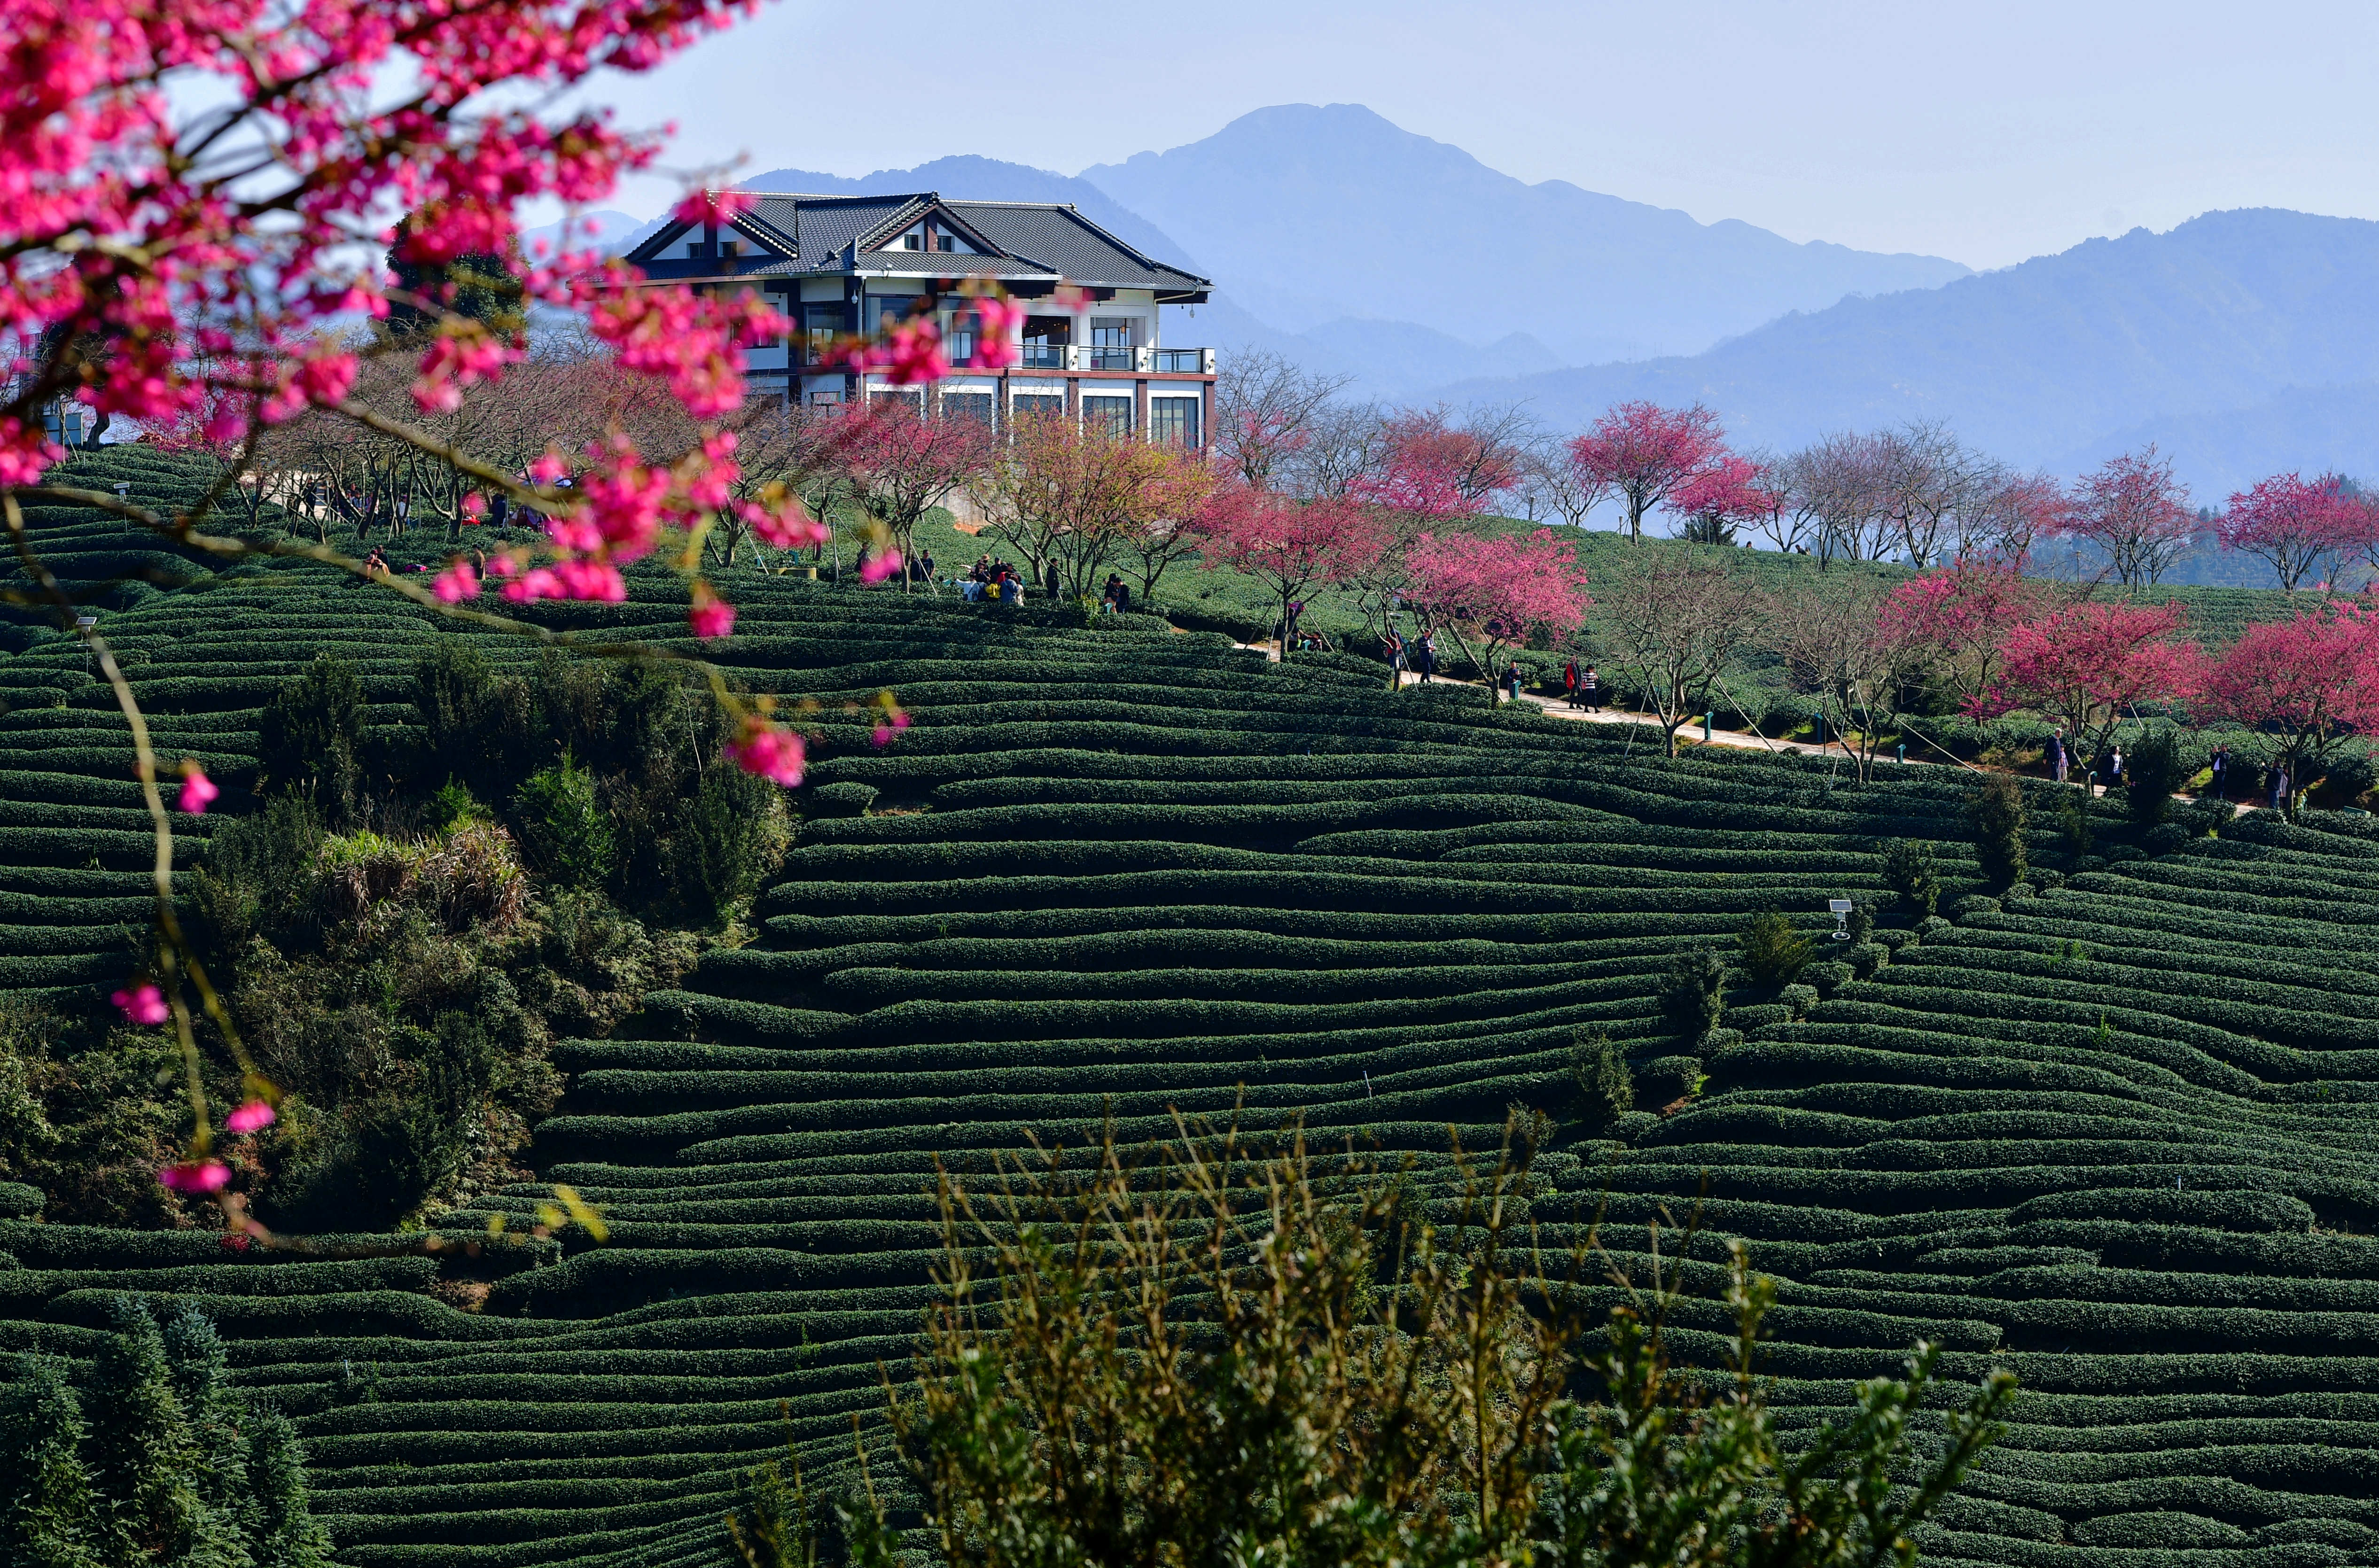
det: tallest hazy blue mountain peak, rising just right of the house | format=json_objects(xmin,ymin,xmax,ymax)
[{"xmin": 1083, "ymin": 105, "xmax": 1970, "ymax": 364}]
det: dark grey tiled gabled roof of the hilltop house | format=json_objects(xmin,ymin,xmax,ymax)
[{"xmin": 628, "ymin": 190, "xmax": 1213, "ymax": 304}]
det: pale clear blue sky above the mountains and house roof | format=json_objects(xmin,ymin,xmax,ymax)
[{"xmin": 571, "ymin": 0, "xmax": 2379, "ymax": 266}]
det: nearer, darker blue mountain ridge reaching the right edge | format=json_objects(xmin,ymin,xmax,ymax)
[{"xmin": 1444, "ymin": 207, "xmax": 2379, "ymax": 500}]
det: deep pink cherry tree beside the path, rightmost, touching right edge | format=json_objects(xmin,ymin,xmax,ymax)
[{"xmin": 2205, "ymin": 599, "xmax": 2379, "ymax": 799}]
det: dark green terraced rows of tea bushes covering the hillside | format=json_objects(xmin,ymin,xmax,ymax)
[{"xmin": 0, "ymin": 450, "xmax": 2379, "ymax": 1568}]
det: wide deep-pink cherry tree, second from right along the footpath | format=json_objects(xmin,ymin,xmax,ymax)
[{"xmin": 1967, "ymin": 599, "xmax": 2205, "ymax": 757}]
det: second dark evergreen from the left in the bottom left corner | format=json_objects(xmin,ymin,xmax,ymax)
[{"xmin": 90, "ymin": 1297, "xmax": 252, "ymax": 1568}]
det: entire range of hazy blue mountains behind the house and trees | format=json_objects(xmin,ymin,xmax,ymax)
[{"xmin": 571, "ymin": 105, "xmax": 2379, "ymax": 500}]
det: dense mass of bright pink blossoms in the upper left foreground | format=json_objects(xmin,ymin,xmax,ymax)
[{"xmin": 0, "ymin": 0, "xmax": 761, "ymax": 485}]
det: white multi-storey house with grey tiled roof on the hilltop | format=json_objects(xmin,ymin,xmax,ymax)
[{"xmin": 628, "ymin": 190, "xmax": 1213, "ymax": 447}]
